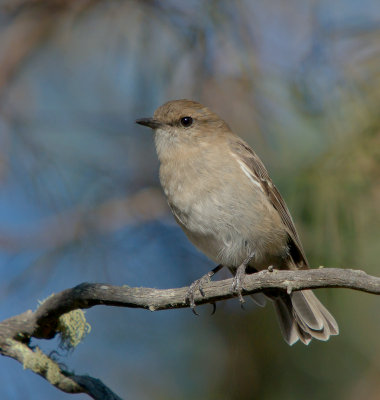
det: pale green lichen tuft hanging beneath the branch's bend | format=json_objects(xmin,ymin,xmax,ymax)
[{"xmin": 57, "ymin": 309, "xmax": 91, "ymax": 350}]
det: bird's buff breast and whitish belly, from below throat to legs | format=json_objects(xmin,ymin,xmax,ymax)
[{"xmin": 160, "ymin": 145, "xmax": 286, "ymax": 265}]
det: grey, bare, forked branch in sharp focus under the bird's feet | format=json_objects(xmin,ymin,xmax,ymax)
[{"xmin": 0, "ymin": 268, "xmax": 380, "ymax": 399}]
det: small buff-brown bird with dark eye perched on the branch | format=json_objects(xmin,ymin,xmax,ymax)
[{"xmin": 136, "ymin": 99, "xmax": 339, "ymax": 345}]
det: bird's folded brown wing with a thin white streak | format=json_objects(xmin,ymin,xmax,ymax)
[{"xmin": 231, "ymin": 138, "xmax": 308, "ymax": 268}]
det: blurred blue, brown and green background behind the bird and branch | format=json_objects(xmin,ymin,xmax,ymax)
[{"xmin": 0, "ymin": 0, "xmax": 380, "ymax": 400}]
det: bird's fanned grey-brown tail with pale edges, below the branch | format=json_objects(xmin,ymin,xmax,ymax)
[{"xmin": 273, "ymin": 290, "xmax": 339, "ymax": 345}]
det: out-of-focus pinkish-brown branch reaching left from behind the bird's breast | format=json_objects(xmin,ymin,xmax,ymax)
[{"xmin": 0, "ymin": 187, "xmax": 169, "ymax": 252}]
